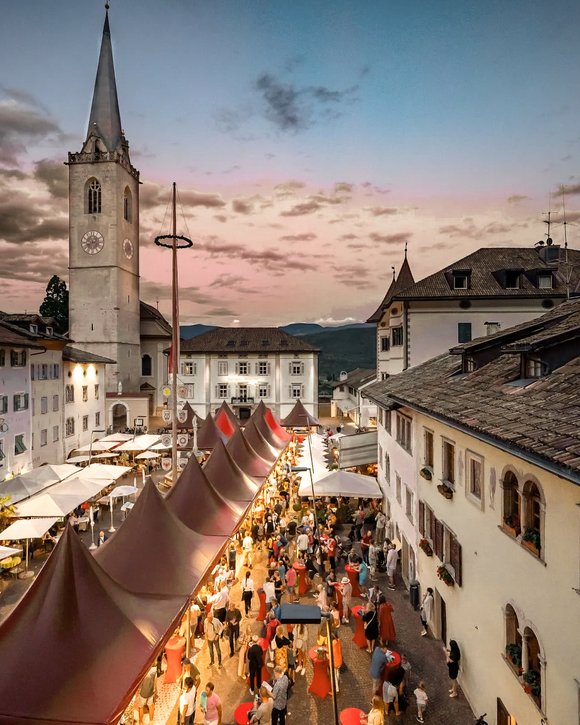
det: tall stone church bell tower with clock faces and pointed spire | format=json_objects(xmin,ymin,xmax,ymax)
[{"xmin": 68, "ymin": 12, "xmax": 141, "ymax": 393}]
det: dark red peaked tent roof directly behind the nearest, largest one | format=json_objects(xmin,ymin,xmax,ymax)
[{"xmin": 95, "ymin": 480, "xmax": 227, "ymax": 597}]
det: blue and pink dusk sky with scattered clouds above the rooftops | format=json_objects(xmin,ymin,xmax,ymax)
[{"xmin": 0, "ymin": 0, "xmax": 580, "ymax": 325}]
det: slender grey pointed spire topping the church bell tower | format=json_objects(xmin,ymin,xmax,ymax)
[{"xmin": 87, "ymin": 4, "xmax": 123, "ymax": 151}]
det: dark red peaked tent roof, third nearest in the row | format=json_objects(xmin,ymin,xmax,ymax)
[{"xmin": 165, "ymin": 456, "xmax": 245, "ymax": 536}]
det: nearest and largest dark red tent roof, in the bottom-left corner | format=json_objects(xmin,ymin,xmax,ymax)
[{"xmin": 0, "ymin": 527, "xmax": 185, "ymax": 725}]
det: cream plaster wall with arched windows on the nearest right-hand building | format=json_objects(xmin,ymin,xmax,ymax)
[{"xmin": 418, "ymin": 416, "xmax": 580, "ymax": 725}]
